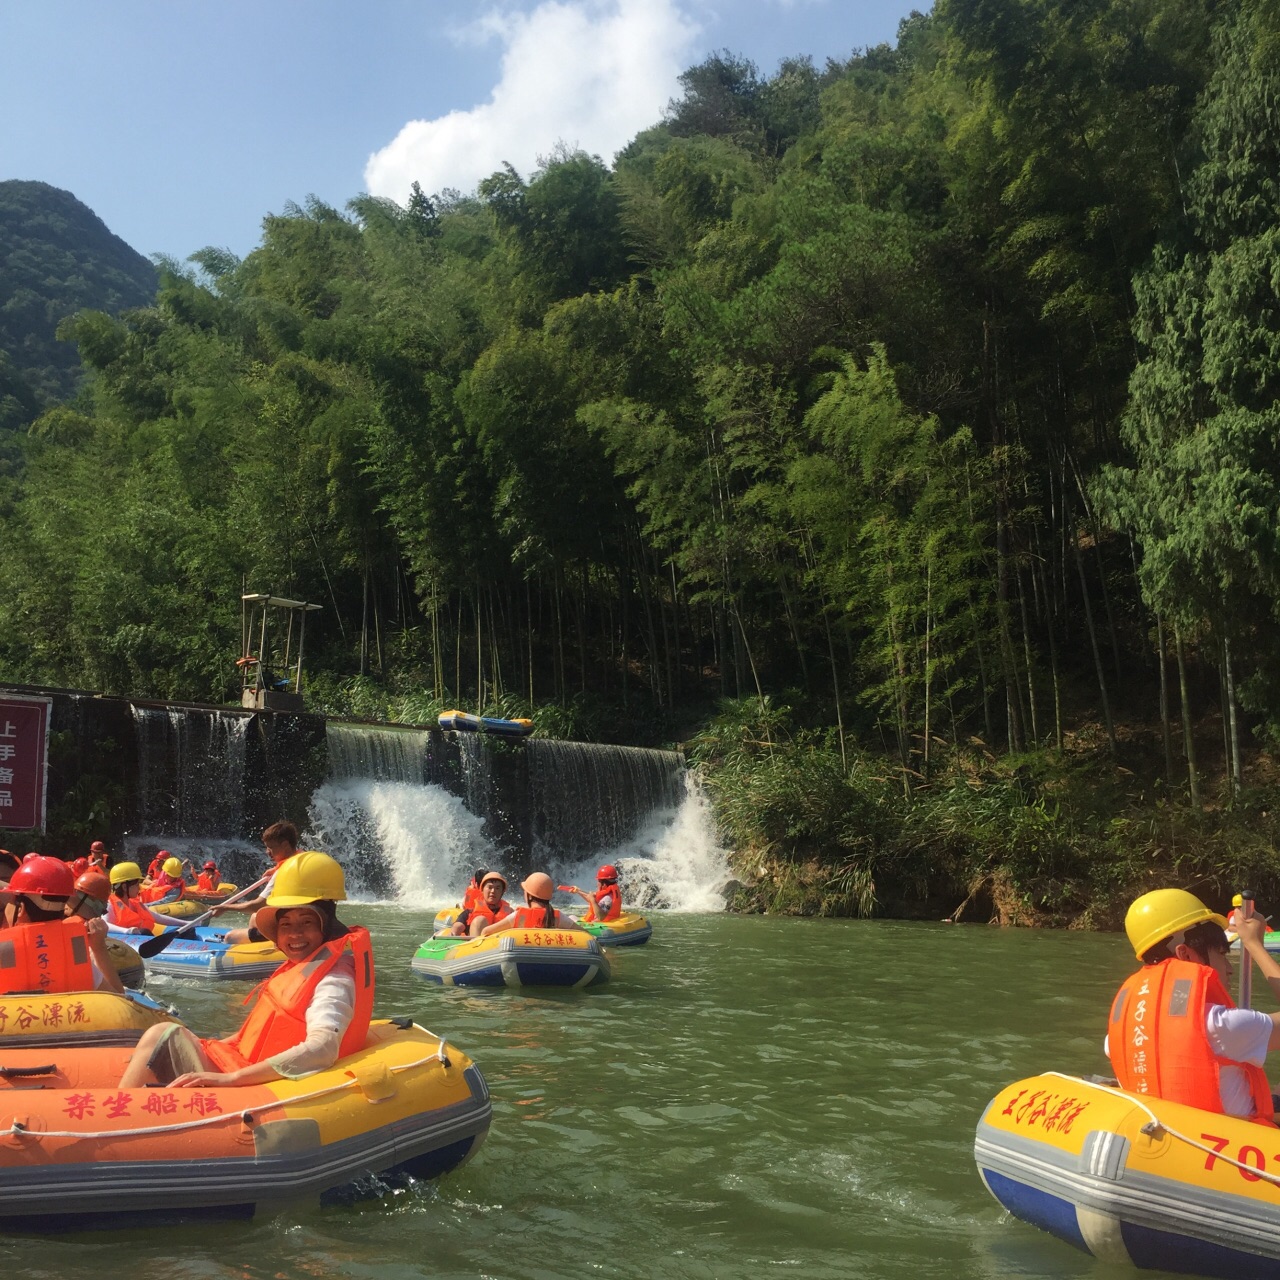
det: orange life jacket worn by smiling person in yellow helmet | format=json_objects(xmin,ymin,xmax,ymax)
[{"xmin": 200, "ymin": 924, "xmax": 374, "ymax": 1071}]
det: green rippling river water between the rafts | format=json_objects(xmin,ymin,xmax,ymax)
[{"xmin": 0, "ymin": 905, "xmax": 1172, "ymax": 1280}]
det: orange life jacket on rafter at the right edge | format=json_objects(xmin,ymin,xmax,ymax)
[{"xmin": 1107, "ymin": 959, "xmax": 1275, "ymax": 1124}]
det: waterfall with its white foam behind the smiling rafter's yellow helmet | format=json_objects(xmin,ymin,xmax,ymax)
[{"xmin": 305, "ymin": 723, "xmax": 498, "ymax": 906}]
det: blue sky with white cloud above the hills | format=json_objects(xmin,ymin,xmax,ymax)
[{"xmin": 0, "ymin": 0, "xmax": 927, "ymax": 257}]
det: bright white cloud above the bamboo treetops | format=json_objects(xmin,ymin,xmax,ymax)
[{"xmin": 365, "ymin": 0, "xmax": 698, "ymax": 202}]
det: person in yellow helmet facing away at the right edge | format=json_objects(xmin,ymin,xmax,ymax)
[{"xmin": 1106, "ymin": 888, "xmax": 1280, "ymax": 1123}]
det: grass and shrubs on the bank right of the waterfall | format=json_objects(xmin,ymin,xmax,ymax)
[{"xmin": 690, "ymin": 699, "xmax": 1280, "ymax": 928}]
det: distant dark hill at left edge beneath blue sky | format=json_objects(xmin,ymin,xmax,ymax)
[{"xmin": 0, "ymin": 180, "xmax": 156, "ymax": 419}]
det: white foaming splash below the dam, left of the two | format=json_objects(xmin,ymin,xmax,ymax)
[{"xmin": 303, "ymin": 778, "xmax": 499, "ymax": 908}]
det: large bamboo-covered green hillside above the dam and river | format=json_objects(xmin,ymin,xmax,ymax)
[{"xmin": 0, "ymin": 0, "xmax": 1280, "ymax": 919}]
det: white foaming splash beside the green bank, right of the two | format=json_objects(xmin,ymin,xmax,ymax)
[{"xmin": 552, "ymin": 773, "xmax": 732, "ymax": 911}]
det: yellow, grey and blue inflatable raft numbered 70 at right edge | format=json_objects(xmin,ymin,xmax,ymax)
[{"xmin": 974, "ymin": 1071, "xmax": 1280, "ymax": 1280}]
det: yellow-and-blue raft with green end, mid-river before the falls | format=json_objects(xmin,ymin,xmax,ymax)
[{"xmin": 412, "ymin": 929, "xmax": 609, "ymax": 987}]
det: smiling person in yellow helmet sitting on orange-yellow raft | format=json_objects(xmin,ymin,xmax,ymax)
[{"xmin": 120, "ymin": 850, "xmax": 374, "ymax": 1088}]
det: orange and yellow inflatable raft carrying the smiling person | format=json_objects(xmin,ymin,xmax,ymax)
[{"xmin": 0, "ymin": 1019, "xmax": 490, "ymax": 1233}]
